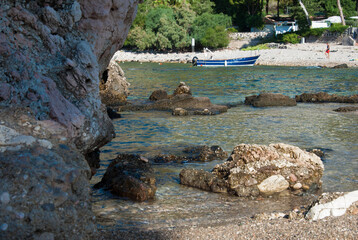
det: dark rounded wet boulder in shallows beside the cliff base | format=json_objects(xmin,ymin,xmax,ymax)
[{"xmin": 95, "ymin": 154, "xmax": 157, "ymax": 201}]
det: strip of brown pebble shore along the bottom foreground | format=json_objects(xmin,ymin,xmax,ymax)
[{"xmin": 98, "ymin": 215, "xmax": 358, "ymax": 240}]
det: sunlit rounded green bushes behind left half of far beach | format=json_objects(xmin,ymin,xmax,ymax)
[{"xmin": 125, "ymin": 0, "xmax": 232, "ymax": 50}]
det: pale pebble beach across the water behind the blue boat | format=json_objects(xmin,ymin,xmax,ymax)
[{"xmin": 113, "ymin": 43, "xmax": 358, "ymax": 67}]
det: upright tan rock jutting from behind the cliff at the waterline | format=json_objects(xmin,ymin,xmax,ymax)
[{"xmin": 100, "ymin": 60, "xmax": 129, "ymax": 106}]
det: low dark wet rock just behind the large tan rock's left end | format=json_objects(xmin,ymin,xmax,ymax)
[{"xmin": 151, "ymin": 145, "xmax": 227, "ymax": 162}]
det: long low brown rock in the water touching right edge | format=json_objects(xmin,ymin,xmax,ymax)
[{"xmin": 296, "ymin": 92, "xmax": 358, "ymax": 103}]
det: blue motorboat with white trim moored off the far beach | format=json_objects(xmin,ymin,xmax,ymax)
[{"xmin": 192, "ymin": 55, "xmax": 260, "ymax": 67}]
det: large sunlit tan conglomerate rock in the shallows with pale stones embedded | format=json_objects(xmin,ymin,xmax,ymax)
[{"xmin": 180, "ymin": 143, "xmax": 324, "ymax": 197}]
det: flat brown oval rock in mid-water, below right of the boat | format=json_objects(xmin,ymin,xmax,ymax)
[{"xmin": 245, "ymin": 93, "xmax": 297, "ymax": 107}]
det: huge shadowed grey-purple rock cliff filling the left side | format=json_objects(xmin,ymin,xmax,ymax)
[{"xmin": 0, "ymin": 0, "xmax": 140, "ymax": 239}]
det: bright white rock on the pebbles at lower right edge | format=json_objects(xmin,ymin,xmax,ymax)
[{"xmin": 306, "ymin": 191, "xmax": 358, "ymax": 221}]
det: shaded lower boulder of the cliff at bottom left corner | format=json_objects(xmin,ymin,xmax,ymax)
[{"xmin": 0, "ymin": 114, "xmax": 96, "ymax": 239}]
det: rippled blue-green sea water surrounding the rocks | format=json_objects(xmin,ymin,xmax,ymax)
[{"xmin": 93, "ymin": 63, "xmax": 358, "ymax": 229}]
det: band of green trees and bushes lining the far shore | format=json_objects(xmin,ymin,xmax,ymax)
[{"xmin": 125, "ymin": 0, "xmax": 358, "ymax": 51}]
